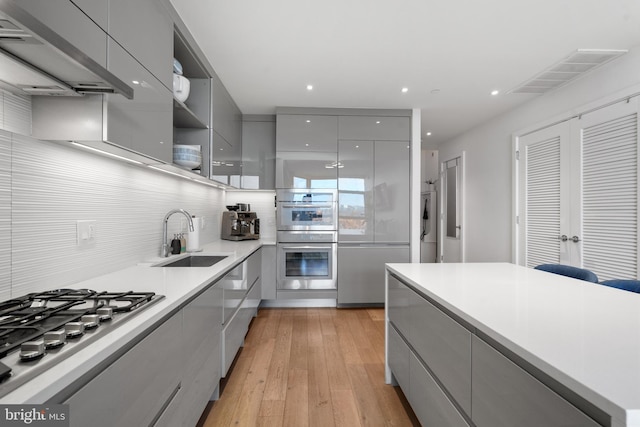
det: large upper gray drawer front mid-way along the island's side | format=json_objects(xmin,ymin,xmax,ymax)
[{"xmin": 407, "ymin": 292, "xmax": 471, "ymax": 413}]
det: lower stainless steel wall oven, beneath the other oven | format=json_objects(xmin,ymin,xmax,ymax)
[{"xmin": 276, "ymin": 231, "xmax": 338, "ymax": 290}]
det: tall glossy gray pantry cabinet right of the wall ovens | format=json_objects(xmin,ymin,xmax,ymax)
[{"xmin": 338, "ymin": 116, "xmax": 411, "ymax": 306}]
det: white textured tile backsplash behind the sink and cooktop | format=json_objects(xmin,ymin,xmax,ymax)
[{"xmin": 0, "ymin": 130, "xmax": 225, "ymax": 300}]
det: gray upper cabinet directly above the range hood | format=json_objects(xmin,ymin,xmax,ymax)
[{"xmin": 19, "ymin": 0, "xmax": 107, "ymax": 67}]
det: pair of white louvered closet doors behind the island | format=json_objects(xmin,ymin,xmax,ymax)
[{"xmin": 517, "ymin": 98, "xmax": 640, "ymax": 280}]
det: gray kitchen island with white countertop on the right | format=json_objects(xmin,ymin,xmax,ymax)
[{"xmin": 386, "ymin": 263, "xmax": 640, "ymax": 427}]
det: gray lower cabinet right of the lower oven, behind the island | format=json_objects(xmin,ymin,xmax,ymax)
[{"xmin": 338, "ymin": 244, "xmax": 410, "ymax": 305}]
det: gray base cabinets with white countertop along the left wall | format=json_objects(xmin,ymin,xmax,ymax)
[{"xmin": 0, "ymin": 240, "xmax": 262, "ymax": 426}]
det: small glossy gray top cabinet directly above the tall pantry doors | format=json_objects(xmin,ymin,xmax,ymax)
[{"xmin": 338, "ymin": 116, "xmax": 411, "ymax": 141}]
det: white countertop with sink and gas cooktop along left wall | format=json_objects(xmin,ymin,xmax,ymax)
[{"xmin": 0, "ymin": 240, "xmax": 262, "ymax": 404}]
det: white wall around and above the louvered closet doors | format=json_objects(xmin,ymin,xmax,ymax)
[{"xmin": 438, "ymin": 46, "xmax": 640, "ymax": 262}]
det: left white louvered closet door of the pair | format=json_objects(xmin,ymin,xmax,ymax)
[{"xmin": 518, "ymin": 123, "xmax": 570, "ymax": 267}]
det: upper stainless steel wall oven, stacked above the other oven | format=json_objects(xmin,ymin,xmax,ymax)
[{"xmin": 276, "ymin": 189, "xmax": 338, "ymax": 231}]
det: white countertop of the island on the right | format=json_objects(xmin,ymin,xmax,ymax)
[{"xmin": 387, "ymin": 263, "xmax": 640, "ymax": 427}]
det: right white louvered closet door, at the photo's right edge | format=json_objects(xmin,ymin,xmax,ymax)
[{"xmin": 570, "ymin": 98, "xmax": 638, "ymax": 280}]
